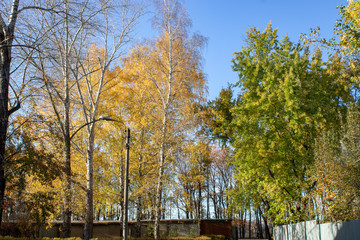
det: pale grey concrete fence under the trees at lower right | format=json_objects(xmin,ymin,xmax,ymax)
[{"xmin": 274, "ymin": 219, "xmax": 360, "ymax": 240}]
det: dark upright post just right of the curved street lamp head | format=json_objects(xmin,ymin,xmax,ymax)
[{"xmin": 123, "ymin": 128, "xmax": 130, "ymax": 240}]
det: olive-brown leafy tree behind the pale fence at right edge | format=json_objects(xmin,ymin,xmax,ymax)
[{"xmin": 312, "ymin": 103, "xmax": 360, "ymax": 221}]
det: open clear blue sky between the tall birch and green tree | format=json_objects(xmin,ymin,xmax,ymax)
[{"xmin": 137, "ymin": 0, "xmax": 347, "ymax": 100}]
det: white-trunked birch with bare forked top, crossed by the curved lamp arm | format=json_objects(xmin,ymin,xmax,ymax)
[{"xmin": 71, "ymin": 0, "xmax": 142, "ymax": 239}]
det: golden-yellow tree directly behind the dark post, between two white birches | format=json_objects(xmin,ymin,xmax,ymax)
[{"xmin": 109, "ymin": 73, "xmax": 157, "ymax": 237}]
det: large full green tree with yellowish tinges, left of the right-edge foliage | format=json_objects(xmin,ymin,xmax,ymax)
[{"xmin": 232, "ymin": 25, "xmax": 349, "ymax": 223}]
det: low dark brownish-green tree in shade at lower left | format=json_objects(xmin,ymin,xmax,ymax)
[{"xmin": 4, "ymin": 116, "xmax": 63, "ymax": 236}]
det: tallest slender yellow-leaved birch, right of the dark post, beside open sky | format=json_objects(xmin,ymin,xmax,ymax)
[{"xmin": 151, "ymin": 0, "xmax": 204, "ymax": 235}]
